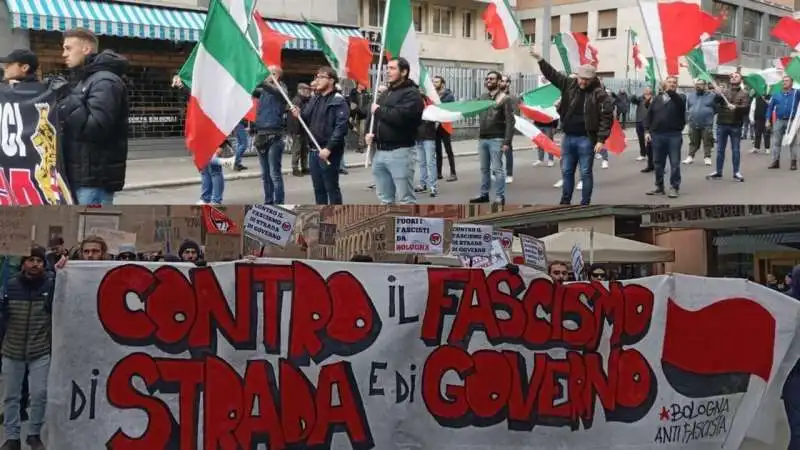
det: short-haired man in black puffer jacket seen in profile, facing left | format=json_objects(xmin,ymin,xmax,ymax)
[{"xmin": 58, "ymin": 28, "xmax": 128, "ymax": 205}]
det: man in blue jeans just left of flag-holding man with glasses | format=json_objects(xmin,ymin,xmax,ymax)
[{"xmin": 254, "ymin": 66, "xmax": 287, "ymax": 205}]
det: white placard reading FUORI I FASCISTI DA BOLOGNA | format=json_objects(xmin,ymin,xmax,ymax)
[{"xmin": 394, "ymin": 216, "xmax": 444, "ymax": 255}]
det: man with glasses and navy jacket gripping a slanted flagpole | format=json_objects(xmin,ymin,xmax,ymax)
[{"xmin": 291, "ymin": 67, "xmax": 350, "ymax": 205}]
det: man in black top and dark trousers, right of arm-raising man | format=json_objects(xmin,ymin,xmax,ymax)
[{"xmin": 644, "ymin": 75, "xmax": 686, "ymax": 198}]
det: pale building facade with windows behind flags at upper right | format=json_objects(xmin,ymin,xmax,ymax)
[{"xmin": 518, "ymin": 0, "xmax": 794, "ymax": 85}]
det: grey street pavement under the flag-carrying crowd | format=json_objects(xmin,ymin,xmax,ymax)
[{"xmin": 116, "ymin": 130, "xmax": 800, "ymax": 205}]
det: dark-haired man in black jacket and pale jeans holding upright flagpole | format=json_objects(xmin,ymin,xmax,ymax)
[{"xmin": 366, "ymin": 58, "xmax": 425, "ymax": 205}]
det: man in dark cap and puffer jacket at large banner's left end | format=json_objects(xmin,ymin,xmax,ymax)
[{"xmin": 0, "ymin": 246, "xmax": 55, "ymax": 450}]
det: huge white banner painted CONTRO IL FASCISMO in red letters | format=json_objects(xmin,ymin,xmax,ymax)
[{"xmin": 47, "ymin": 259, "xmax": 800, "ymax": 450}]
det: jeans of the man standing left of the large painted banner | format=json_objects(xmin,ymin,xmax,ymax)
[{"xmin": 3, "ymin": 355, "xmax": 50, "ymax": 440}]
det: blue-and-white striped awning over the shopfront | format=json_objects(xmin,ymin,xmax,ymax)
[{"xmin": 5, "ymin": 0, "xmax": 361, "ymax": 50}]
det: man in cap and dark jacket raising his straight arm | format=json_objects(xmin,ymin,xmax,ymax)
[{"xmin": 530, "ymin": 47, "xmax": 614, "ymax": 205}]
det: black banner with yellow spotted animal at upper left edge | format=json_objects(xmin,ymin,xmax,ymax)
[{"xmin": 0, "ymin": 83, "xmax": 72, "ymax": 206}]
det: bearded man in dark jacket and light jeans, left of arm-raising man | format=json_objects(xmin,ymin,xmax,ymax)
[{"xmin": 470, "ymin": 70, "xmax": 515, "ymax": 205}]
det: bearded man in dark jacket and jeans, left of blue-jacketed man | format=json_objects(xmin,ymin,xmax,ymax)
[{"xmin": 706, "ymin": 72, "xmax": 750, "ymax": 182}]
